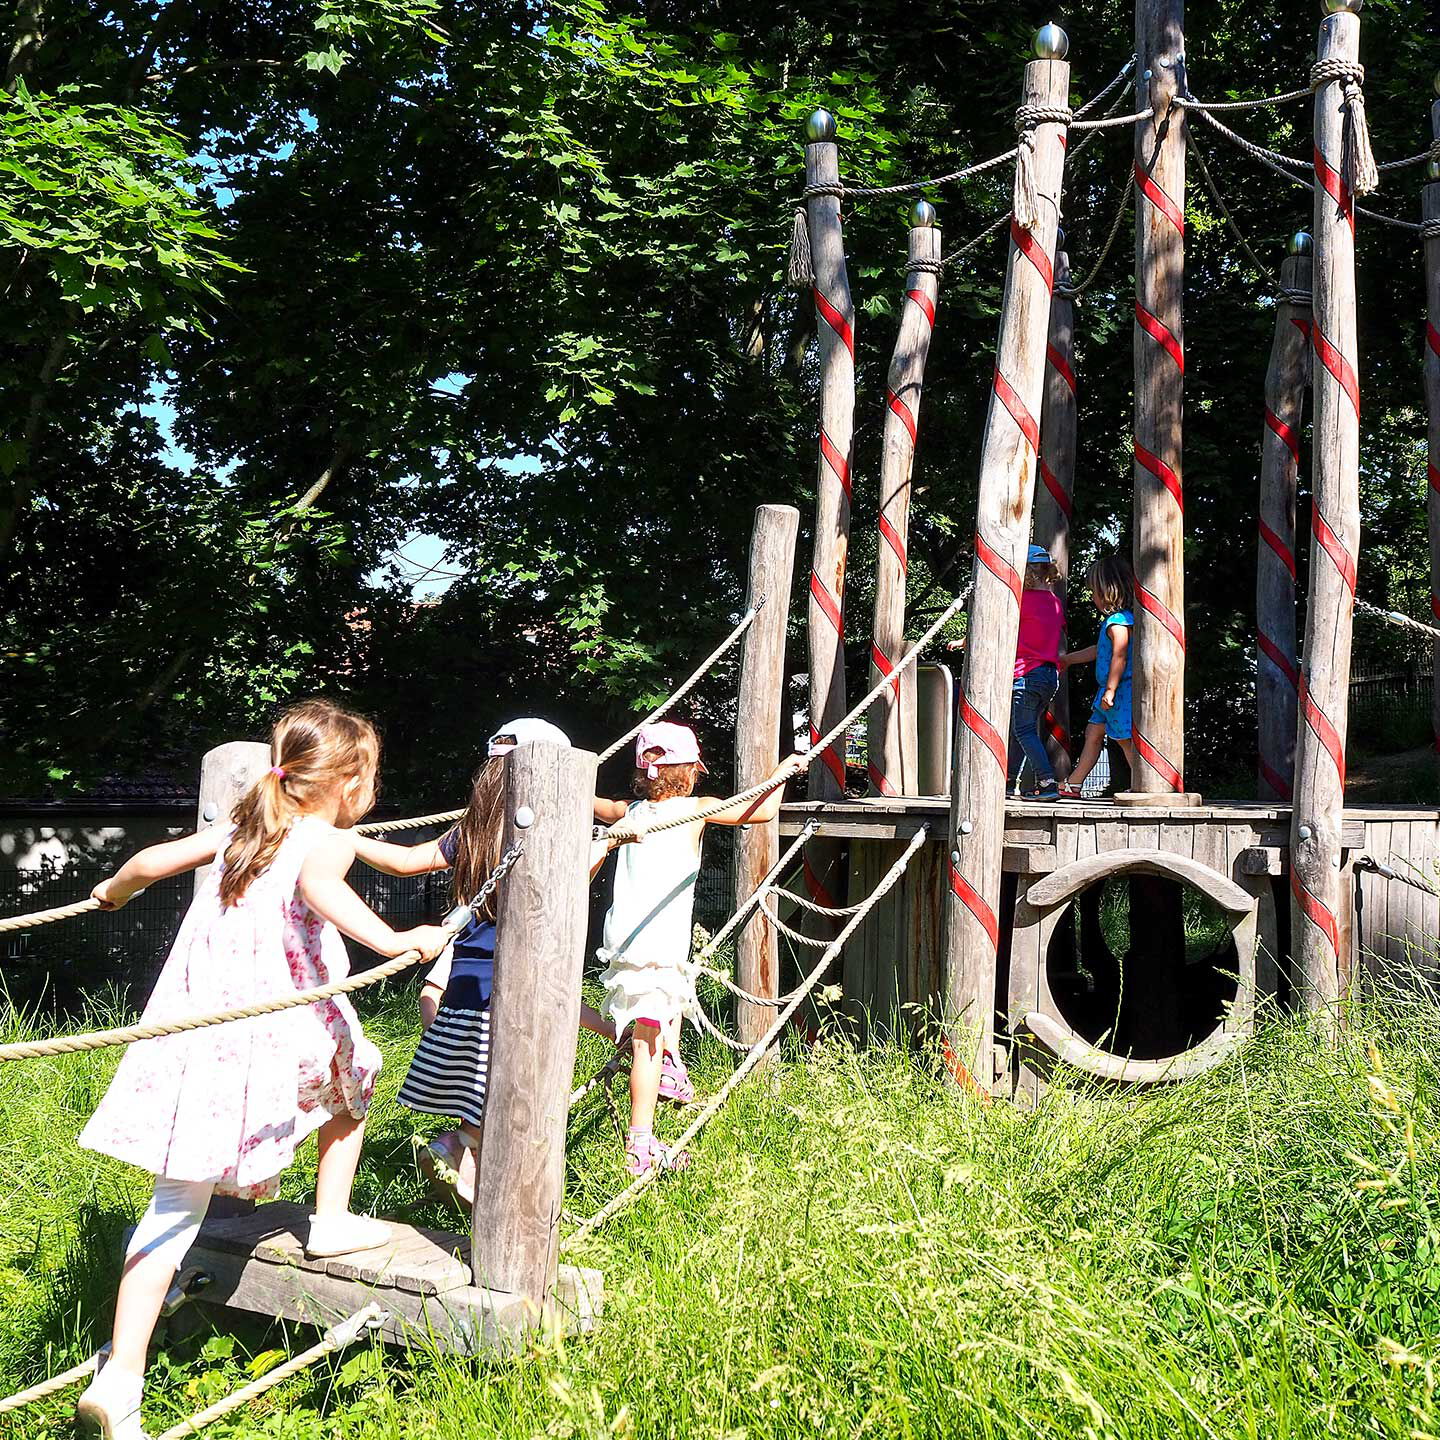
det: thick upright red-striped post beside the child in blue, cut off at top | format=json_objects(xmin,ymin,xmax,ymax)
[{"xmin": 1130, "ymin": 0, "xmax": 1185, "ymax": 791}]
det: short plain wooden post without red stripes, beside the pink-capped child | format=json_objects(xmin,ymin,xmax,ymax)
[{"xmin": 734, "ymin": 505, "xmax": 801, "ymax": 1045}]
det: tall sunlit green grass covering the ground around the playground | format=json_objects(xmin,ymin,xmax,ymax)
[{"xmin": 0, "ymin": 973, "xmax": 1440, "ymax": 1440}]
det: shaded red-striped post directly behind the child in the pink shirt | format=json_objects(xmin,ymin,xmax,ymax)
[{"xmin": 1035, "ymin": 250, "xmax": 1079, "ymax": 780}]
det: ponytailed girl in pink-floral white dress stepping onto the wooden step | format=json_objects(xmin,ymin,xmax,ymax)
[{"xmin": 76, "ymin": 700, "xmax": 448, "ymax": 1440}]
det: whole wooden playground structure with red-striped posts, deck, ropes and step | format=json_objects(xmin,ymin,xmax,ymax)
[{"xmin": 0, "ymin": 0, "xmax": 1440, "ymax": 1408}]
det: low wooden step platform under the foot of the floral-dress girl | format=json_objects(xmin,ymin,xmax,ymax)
[{"xmin": 184, "ymin": 1201, "xmax": 603, "ymax": 1355}]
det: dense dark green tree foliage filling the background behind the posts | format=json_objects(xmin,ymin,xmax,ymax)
[{"xmin": 0, "ymin": 0, "xmax": 1434, "ymax": 801}]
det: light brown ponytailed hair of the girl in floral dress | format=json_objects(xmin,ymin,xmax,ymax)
[{"xmin": 220, "ymin": 700, "xmax": 380, "ymax": 907}]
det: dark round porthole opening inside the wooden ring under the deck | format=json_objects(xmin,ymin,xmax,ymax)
[{"xmin": 1045, "ymin": 874, "xmax": 1240, "ymax": 1060}]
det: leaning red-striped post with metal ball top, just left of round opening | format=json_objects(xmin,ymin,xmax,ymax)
[{"xmin": 942, "ymin": 26, "xmax": 1070, "ymax": 1089}]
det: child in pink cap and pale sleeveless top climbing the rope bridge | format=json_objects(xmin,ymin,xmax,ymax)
[{"xmin": 599, "ymin": 721, "xmax": 801, "ymax": 1175}]
